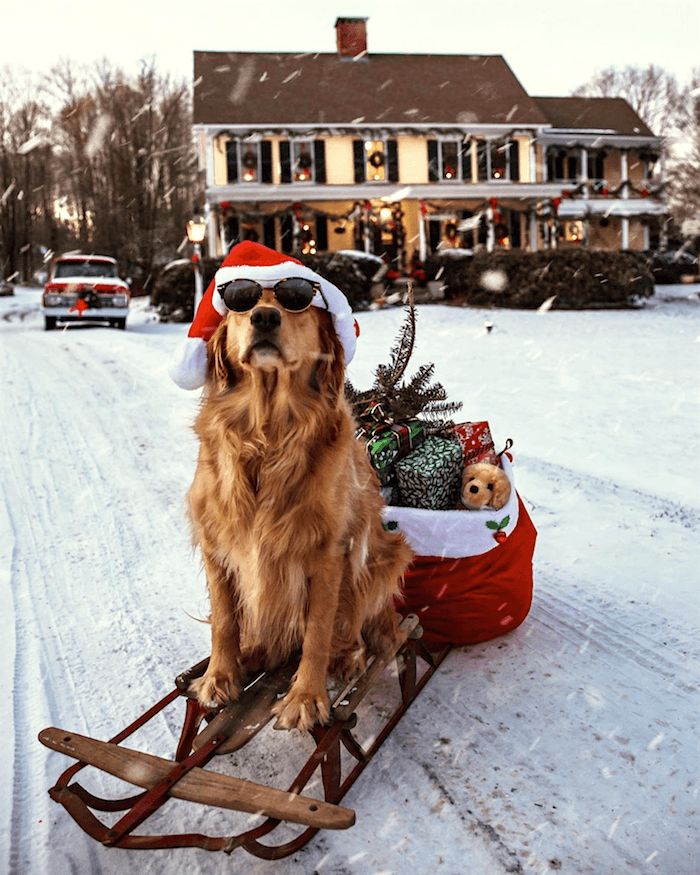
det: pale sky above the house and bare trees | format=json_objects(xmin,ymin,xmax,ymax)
[{"xmin": 0, "ymin": 0, "xmax": 700, "ymax": 95}]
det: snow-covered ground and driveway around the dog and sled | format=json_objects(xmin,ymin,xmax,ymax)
[{"xmin": 0, "ymin": 286, "xmax": 700, "ymax": 875}]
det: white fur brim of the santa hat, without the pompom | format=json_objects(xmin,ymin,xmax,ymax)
[{"xmin": 212, "ymin": 261, "xmax": 357, "ymax": 365}]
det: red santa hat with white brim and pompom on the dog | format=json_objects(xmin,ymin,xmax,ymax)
[{"xmin": 169, "ymin": 241, "xmax": 358, "ymax": 389}]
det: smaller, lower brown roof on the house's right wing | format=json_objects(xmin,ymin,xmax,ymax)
[{"xmin": 533, "ymin": 97, "xmax": 654, "ymax": 137}]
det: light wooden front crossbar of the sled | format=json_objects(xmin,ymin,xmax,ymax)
[{"xmin": 39, "ymin": 727, "xmax": 355, "ymax": 829}]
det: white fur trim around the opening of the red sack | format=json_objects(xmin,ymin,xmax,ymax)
[{"xmin": 383, "ymin": 455, "xmax": 518, "ymax": 559}]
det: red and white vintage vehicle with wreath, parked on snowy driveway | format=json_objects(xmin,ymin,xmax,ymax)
[{"xmin": 42, "ymin": 255, "xmax": 131, "ymax": 331}]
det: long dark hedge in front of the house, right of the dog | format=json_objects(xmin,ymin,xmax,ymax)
[{"xmin": 426, "ymin": 249, "xmax": 654, "ymax": 310}]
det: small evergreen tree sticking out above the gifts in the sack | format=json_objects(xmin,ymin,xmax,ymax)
[{"xmin": 345, "ymin": 286, "xmax": 462, "ymax": 435}]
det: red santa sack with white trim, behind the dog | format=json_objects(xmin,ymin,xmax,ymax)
[{"xmin": 384, "ymin": 453, "xmax": 537, "ymax": 649}]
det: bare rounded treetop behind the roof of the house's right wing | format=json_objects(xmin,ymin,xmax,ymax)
[{"xmin": 573, "ymin": 64, "xmax": 686, "ymax": 136}]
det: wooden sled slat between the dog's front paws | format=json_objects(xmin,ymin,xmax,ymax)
[{"xmin": 192, "ymin": 663, "xmax": 297, "ymax": 756}]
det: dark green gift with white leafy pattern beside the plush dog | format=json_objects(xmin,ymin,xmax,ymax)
[{"xmin": 396, "ymin": 436, "xmax": 463, "ymax": 510}]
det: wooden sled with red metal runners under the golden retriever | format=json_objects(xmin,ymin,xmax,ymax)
[{"xmin": 39, "ymin": 615, "xmax": 450, "ymax": 860}]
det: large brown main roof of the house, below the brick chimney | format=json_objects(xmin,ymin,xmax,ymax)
[{"xmin": 194, "ymin": 52, "xmax": 546, "ymax": 127}]
